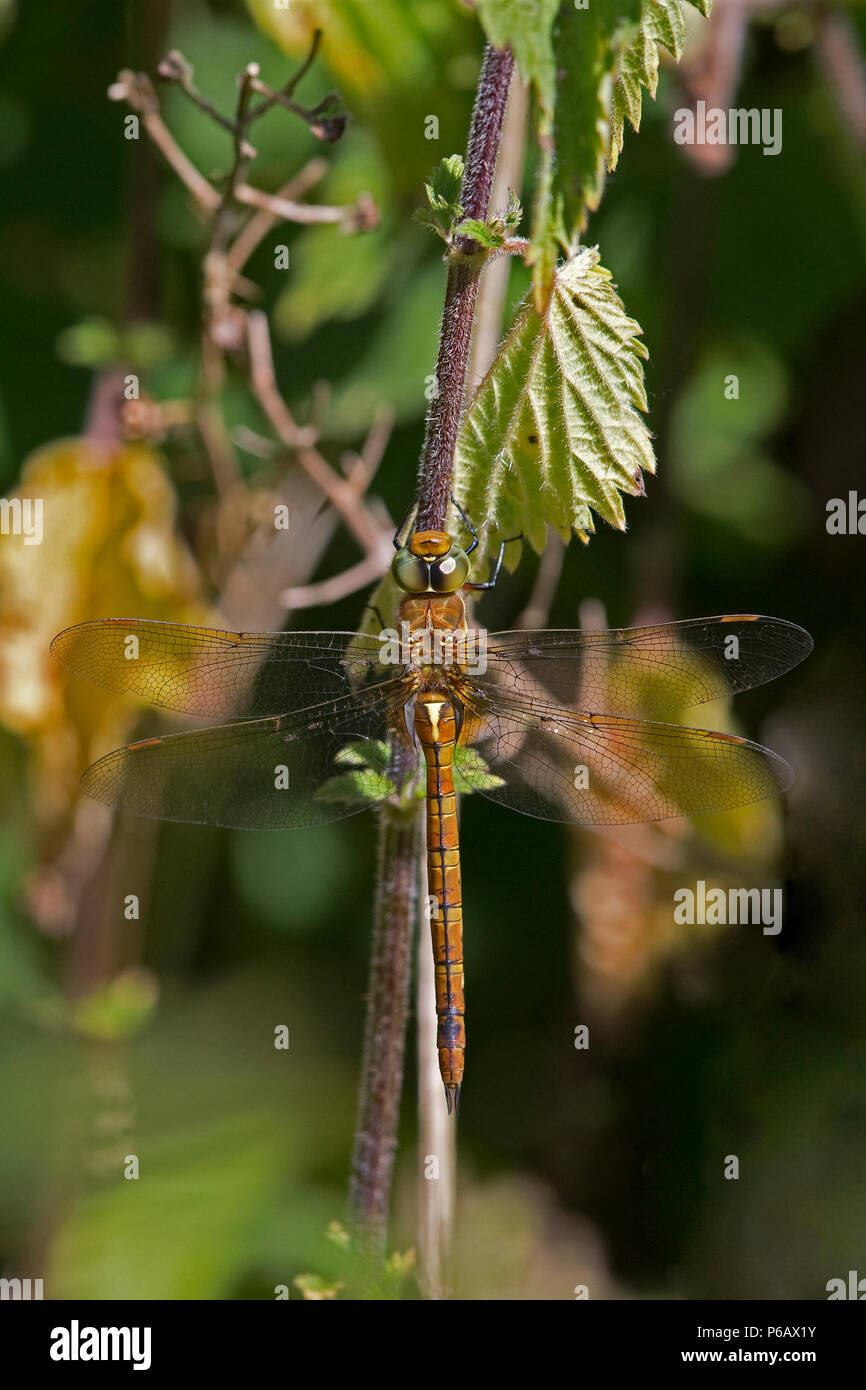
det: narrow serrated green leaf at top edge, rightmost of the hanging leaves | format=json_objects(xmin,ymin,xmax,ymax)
[{"xmin": 607, "ymin": 0, "xmax": 712, "ymax": 170}]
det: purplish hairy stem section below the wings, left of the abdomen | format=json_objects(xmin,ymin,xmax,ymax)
[{"xmin": 349, "ymin": 806, "xmax": 421, "ymax": 1255}]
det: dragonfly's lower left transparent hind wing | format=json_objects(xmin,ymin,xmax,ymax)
[{"xmin": 82, "ymin": 680, "xmax": 414, "ymax": 830}]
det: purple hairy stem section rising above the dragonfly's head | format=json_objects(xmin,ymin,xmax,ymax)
[{"xmin": 416, "ymin": 44, "xmax": 514, "ymax": 531}]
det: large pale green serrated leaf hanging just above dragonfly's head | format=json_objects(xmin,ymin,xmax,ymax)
[{"xmin": 455, "ymin": 247, "xmax": 655, "ymax": 564}]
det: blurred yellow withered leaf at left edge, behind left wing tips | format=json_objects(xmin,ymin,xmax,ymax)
[{"xmin": 0, "ymin": 439, "xmax": 207, "ymax": 819}]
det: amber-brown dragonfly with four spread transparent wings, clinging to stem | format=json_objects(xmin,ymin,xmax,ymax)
[{"xmin": 51, "ymin": 517, "xmax": 812, "ymax": 1113}]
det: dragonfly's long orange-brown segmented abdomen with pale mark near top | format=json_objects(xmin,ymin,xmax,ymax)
[{"xmin": 414, "ymin": 691, "xmax": 466, "ymax": 1112}]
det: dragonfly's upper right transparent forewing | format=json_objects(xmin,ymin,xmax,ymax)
[{"xmin": 473, "ymin": 614, "xmax": 812, "ymax": 719}]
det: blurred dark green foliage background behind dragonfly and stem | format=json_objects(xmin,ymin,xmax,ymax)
[{"xmin": 0, "ymin": 0, "xmax": 866, "ymax": 1298}]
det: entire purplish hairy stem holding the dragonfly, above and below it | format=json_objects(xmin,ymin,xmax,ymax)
[{"xmin": 349, "ymin": 44, "xmax": 513, "ymax": 1254}]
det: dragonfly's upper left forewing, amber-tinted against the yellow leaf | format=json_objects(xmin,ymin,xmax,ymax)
[{"xmin": 51, "ymin": 619, "xmax": 395, "ymax": 719}]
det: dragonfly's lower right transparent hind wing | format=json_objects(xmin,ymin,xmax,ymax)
[{"xmin": 460, "ymin": 685, "xmax": 792, "ymax": 826}]
